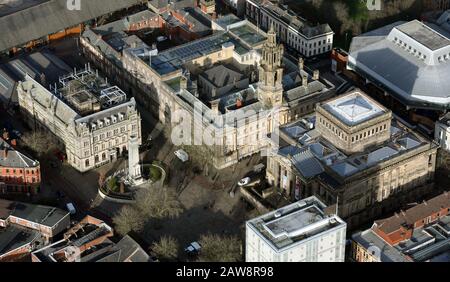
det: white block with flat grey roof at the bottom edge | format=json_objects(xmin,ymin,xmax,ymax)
[{"xmin": 245, "ymin": 196, "xmax": 347, "ymax": 262}]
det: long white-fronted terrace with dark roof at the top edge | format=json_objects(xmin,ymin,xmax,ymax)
[{"xmin": 246, "ymin": 0, "xmax": 334, "ymax": 57}]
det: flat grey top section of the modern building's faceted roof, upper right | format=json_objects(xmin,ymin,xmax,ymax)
[{"xmin": 397, "ymin": 21, "xmax": 450, "ymax": 51}]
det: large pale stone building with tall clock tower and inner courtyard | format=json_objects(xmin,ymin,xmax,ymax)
[{"xmin": 81, "ymin": 21, "xmax": 335, "ymax": 168}]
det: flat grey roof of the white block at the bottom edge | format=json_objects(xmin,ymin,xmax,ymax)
[{"xmin": 247, "ymin": 196, "xmax": 346, "ymax": 250}]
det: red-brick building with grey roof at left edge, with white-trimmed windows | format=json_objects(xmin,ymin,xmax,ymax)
[{"xmin": 0, "ymin": 138, "xmax": 41, "ymax": 194}]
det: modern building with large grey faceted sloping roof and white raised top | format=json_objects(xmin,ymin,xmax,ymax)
[{"xmin": 347, "ymin": 20, "xmax": 450, "ymax": 111}]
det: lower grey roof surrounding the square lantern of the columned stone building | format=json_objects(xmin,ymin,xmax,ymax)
[{"xmin": 276, "ymin": 113, "xmax": 430, "ymax": 180}]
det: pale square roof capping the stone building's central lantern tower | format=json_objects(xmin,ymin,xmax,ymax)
[{"xmin": 322, "ymin": 91, "xmax": 387, "ymax": 126}]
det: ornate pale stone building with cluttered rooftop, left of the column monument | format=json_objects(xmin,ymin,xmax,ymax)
[{"xmin": 17, "ymin": 66, "xmax": 142, "ymax": 172}]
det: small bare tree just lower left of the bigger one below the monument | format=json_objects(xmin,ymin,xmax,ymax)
[{"xmin": 113, "ymin": 206, "xmax": 145, "ymax": 235}]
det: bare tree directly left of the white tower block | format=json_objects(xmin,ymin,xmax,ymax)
[{"xmin": 198, "ymin": 234, "xmax": 242, "ymax": 262}]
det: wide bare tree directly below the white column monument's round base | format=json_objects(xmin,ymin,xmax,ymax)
[{"xmin": 136, "ymin": 187, "xmax": 183, "ymax": 219}]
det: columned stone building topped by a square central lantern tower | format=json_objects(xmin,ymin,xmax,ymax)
[{"xmin": 267, "ymin": 90, "xmax": 438, "ymax": 228}]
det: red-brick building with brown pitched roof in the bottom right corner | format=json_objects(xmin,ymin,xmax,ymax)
[{"xmin": 351, "ymin": 192, "xmax": 450, "ymax": 262}]
